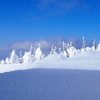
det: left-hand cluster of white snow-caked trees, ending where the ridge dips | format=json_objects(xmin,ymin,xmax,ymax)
[{"xmin": 0, "ymin": 44, "xmax": 45, "ymax": 64}]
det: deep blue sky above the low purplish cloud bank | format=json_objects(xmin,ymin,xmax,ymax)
[{"xmin": 0, "ymin": 0, "xmax": 100, "ymax": 57}]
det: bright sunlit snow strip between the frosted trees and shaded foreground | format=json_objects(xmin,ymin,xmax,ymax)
[{"xmin": 0, "ymin": 50, "xmax": 100, "ymax": 73}]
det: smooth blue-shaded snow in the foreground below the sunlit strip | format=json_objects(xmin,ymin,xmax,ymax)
[{"xmin": 0, "ymin": 69, "xmax": 100, "ymax": 100}]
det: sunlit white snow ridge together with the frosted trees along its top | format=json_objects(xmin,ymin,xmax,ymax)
[{"xmin": 0, "ymin": 38, "xmax": 100, "ymax": 73}]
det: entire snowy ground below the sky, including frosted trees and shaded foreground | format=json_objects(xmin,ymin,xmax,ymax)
[{"xmin": 0, "ymin": 41, "xmax": 100, "ymax": 100}]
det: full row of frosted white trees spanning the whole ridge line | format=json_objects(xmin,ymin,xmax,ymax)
[{"xmin": 0, "ymin": 37, "xmax": 100, "ymax": 64}]
